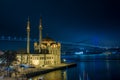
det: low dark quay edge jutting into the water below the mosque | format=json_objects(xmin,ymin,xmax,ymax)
[{"xmin": 21, "ymin": 63, "xmax": 77, "ymax": 78}]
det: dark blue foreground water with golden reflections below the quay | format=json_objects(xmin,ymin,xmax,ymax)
[{"xmin": 28, "ymin": 61, "xmax": 120, "ymax": 80}]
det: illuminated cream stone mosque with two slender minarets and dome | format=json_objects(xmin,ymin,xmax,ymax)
[{"xmin": 16, "ymin": 18, "xmax": 61, "ymax": 67}]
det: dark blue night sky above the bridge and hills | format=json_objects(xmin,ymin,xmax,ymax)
[{"xmin": 0, "ymin": 0, "xmax": 120, "ymax": 46}]
